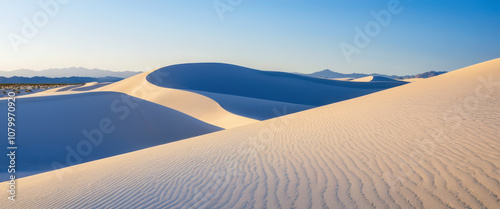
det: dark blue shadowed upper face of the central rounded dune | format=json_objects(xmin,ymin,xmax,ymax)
[{"xmin": 147, "ymin": 63, "xmax": 405, "ymax": 106}]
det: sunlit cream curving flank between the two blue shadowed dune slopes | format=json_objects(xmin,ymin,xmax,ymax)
[{"xmin": 92, "ymin": 71, "xmax": 258, "ymax": 129}]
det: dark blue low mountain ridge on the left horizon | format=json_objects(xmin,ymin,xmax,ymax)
[{"xmin": 0, "ymin": 76, "xmax": 123, "ymax": 84}]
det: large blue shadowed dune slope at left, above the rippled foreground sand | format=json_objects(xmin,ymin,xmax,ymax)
[{"xmin": 0, "ymin": 92, "xmax": 222, "ymax": 181}]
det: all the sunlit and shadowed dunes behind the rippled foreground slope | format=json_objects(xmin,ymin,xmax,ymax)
[{"xmin": 0, "ymin": 63, "xmax": 398, "ymax": 181}]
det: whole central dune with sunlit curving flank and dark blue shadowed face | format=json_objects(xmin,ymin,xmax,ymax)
[{"xmin": 94, "ymin": 63, "xmax": 403, "ymax": 125}]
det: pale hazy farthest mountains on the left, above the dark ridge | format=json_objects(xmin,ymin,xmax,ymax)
[{"xmin": 0, "ymin": 67, "xmax": 141, "ymax": 78}]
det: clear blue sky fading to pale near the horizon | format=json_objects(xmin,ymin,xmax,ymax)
[{"xmin": 0, "ymin": 0, "xmax": 500, "ymax": 75}]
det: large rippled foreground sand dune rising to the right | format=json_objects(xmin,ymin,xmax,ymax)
[{"xmin": 4, "ymin": 59, "xmax": 500, "ymax": 208}]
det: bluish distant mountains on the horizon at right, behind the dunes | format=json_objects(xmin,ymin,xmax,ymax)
[{"xmin": 306, "ymin": 69, "xmax": 446, "ymax": 79}]
